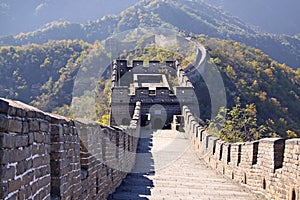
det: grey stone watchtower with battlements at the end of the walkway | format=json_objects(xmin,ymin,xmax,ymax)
[{"xmin": 110, "ymin": 60, "xmax": 195, "ymax": 129}]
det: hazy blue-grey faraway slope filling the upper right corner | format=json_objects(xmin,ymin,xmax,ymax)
[{"xmin": 204, "ymin": 0, "xmax": 300, "ymax": 35}]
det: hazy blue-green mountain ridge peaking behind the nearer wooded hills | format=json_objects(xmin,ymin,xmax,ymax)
[{"xmin": 0, "ymin": 0, "xmax": 300, "ymax": 68}]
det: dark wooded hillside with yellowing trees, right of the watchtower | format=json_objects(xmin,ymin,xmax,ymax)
[{"xmin": 199, "ymin": 38, "xmax": 300, "ymax": 137}]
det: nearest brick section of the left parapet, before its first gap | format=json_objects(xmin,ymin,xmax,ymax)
[{"xmin": 0, "ymin": 99, "xmax": 51, "ymax": 199}]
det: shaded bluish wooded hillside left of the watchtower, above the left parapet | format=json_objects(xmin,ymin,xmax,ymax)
[{"xmin": 0, "ymin": 40, "xmax": 92, "ymax": 111}]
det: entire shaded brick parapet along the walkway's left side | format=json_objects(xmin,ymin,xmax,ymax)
[{"xmin": 0, "ymin": 99, "xmax": 140, "ymax": 199}]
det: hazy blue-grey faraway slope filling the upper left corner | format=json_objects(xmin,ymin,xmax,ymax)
[{"xmin": 0, "ymin": 0, "xmax": 138, "ymax": 36}]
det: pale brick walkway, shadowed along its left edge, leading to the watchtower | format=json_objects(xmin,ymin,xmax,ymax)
[{"xmin": 109, "ymin": 130, "xmax": 259, "ymax": 200}]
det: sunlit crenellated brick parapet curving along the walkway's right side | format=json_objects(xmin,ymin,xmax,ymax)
[{"xmin": 182, "ymin": 106, "xmax": 300, "ymax": 200}]
